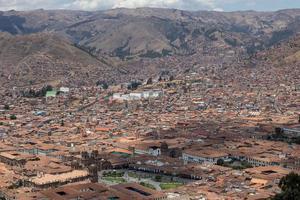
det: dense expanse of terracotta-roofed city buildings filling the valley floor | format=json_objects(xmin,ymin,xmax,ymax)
[{"xmin": 0, "ymin": 72, "xmax": 300, "ymax": 200}]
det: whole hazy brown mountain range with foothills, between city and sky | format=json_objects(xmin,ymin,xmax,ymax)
[{"xmin": 0, "ymin": 8, "xmax": 300, "ymax": 87}]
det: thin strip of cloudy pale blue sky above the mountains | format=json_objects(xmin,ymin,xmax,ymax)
[{"xmin": 0, "ymin": 0, "xmax": 300, "ymax": 11}]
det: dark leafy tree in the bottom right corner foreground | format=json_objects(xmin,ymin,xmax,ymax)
[{"xmin": 273, "ymin": 172, "xmax": 300, "ymax": 200}]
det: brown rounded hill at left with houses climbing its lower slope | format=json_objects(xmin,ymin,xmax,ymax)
[{"xmin": 0, "ymin": 33, "xmax": 112, "ymax": 86}]
